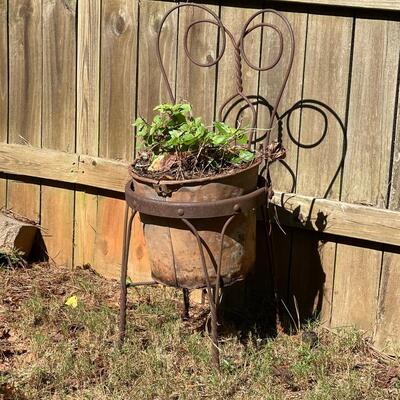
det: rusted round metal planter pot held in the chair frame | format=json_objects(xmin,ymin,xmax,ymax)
[{"xmin": 131, "ymin": 162, "xmax": 260, "ymax": 289}]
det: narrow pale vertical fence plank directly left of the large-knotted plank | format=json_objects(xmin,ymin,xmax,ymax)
[{"xmin": 74, "ymin": 0, "xmax": 101, "ymax": 265}]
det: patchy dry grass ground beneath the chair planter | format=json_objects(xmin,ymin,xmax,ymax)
[{"xmin": 0, "ymin": 264, "xmax": 400, "ymax": 400}]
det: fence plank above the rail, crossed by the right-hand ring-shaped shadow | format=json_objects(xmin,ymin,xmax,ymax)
[{"xmin": 296, "ymin": 14, "xmax": 353, "ymax": 199}]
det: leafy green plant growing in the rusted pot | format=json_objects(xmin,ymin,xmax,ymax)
[{"xmin": 134, "ymin": 103, "xmax": 255, "ymax": 177}]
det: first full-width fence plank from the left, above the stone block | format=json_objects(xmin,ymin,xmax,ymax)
[{"xmin": 7, "ymin": 0, "xmax": 42, "ymax": 222}]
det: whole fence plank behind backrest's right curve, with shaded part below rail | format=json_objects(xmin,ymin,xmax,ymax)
[{"xmin": 257, "ymin": 12, "xmax": 307, "ymax": 320}]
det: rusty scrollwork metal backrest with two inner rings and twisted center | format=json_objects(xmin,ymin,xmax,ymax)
[{"xmin": 156, "ymin": 3, "xmax": 294, "ymax": 162}]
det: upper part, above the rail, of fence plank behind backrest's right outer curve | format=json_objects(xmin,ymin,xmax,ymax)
[{"xmin": 258, "ymin": 12, "xmax": 308, "ymax": 193}]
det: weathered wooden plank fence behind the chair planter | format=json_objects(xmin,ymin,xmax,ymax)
[{"xmin": 0, "ymin": 0, "xmax": 400, "ymax": 351}]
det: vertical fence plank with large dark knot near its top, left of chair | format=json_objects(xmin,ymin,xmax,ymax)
[{"xmin": 94, "ymin": 0, "xmax": 137, "ymax": 277}]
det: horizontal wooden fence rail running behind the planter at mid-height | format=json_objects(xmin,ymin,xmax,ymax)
[{"xmin": 0, "ymin": 144, "xmax": 400, "ymax": 246}]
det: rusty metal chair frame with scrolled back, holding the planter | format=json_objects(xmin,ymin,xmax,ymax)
[{"xmin": 119, "ymin": 3, "xmax": 294, "ymax": 366}]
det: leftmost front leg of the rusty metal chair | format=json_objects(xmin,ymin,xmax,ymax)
[{"xmin": 118, "ymin": 204, "xmax": 136, "ymax": 346}]
